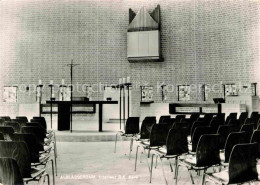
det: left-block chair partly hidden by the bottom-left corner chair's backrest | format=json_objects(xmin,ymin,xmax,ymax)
[{"xmin": 0, "ymin": 141, "xmax": 50, "ymax": 184}]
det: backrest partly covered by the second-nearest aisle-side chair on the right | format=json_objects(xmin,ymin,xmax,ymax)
[{"xmin": 191, "ymin": 126, "xmax": 215, "ymax": 152}]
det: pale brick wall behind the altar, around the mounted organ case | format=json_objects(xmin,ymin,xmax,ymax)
[{"xmin": 0, "ymin": 0, "xmax": 260, "ymax": 118}]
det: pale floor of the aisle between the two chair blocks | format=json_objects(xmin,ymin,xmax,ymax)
[{"xmin": 49, "ymin": 141, "xmax": 213, "ymax": 185}]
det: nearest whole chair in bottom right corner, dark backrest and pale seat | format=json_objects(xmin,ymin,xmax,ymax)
[{"xmin": 206, "ymin": 143, "xmax": 258, "ymax": 185}]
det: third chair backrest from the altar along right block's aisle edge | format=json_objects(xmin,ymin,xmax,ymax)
[{"xmin": 150, "ymin": 124, "xmax": 168, "ymax": 146}]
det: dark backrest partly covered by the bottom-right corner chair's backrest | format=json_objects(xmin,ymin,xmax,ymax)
[{"xmin": 224, "ymin": 132, "xmax": 246, "ymax": 163}]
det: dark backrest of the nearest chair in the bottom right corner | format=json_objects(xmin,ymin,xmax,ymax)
[{"xmin": 228, "ymin": 143, "xmax": 258, "ymax": 184}]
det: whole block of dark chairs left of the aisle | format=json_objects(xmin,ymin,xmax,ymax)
[{"xmin": 0, "ymin": 116, "xmax": 57, "ymax": 184}]
